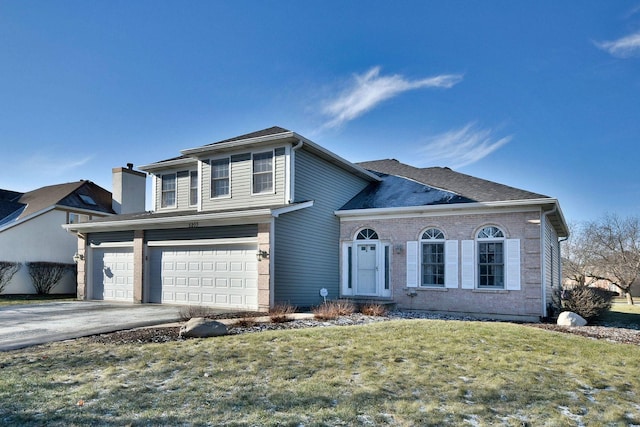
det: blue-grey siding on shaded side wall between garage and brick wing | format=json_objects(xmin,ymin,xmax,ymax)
[{"xmin": 272, "ymin": 150, "xmax": 368, "ymax": 307}]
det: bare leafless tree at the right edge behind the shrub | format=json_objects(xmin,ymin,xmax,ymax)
[{"xmin": 584, "ymin": 214, "xmax": 640, "ymax": 304}]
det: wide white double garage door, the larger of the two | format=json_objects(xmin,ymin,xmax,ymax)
[{"xmin": 149, "ymin": 244, "xmax": 258, "ymax": 310}]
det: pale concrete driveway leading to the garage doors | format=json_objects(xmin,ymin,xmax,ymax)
[{"xmin": 0, "ymin": 301, "xmax": 189, "ymax": 351}]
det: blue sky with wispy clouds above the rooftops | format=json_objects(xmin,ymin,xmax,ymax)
[{"xmin": 0, "ymin": 0, "xmax": 640, "ymax": 221}]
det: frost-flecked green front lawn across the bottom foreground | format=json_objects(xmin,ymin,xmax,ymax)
[{"xmin": 0, "ymin": 320, "xmax": 640, "ymax": 426}]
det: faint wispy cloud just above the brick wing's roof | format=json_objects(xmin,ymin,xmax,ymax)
[{"xmin": 420, "ymin": 123, "xmax": 512, "ymax": 169}]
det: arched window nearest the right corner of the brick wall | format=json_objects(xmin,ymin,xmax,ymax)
[{"xmin": 478, "ymin": 227, "xmax": 504, "ymax": 289}]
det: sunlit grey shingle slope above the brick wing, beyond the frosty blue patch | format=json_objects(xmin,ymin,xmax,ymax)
[{"xmin": 358, "ymin": 159, "xmax": 549, "ymax": 203}]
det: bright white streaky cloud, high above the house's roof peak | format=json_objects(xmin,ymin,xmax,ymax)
[{"xmin": 323, "ymin": 67, "xmax": 462, "ymax": 128}]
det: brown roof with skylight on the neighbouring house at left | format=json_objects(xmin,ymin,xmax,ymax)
[{"xmin": 0, "ymin": 180, "xmax": 115, "ymax": 224}]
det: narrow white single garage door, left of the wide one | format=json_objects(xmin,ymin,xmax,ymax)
[{"xmin": 89, "ymin": 248, "xmax": 133, "ymax": 301}]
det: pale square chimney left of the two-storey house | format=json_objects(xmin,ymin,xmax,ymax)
[{"xmin": 111, "ymin": 163, "xmax": 147, "ymax": 214}]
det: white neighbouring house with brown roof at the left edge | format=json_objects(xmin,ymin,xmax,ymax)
[{"xmin": 0, "ymin": 168, "xmax": 145, "ymax": 294}]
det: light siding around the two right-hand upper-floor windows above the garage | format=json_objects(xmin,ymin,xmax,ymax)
[{"xmin": 200, "ymin": 145, "xmax": 287, "ymax": 211}]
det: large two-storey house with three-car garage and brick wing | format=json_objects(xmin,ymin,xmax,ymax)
[{"xmin": 65, "ymin": 127, "xmax": 567, "ymax": 319}]
